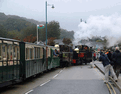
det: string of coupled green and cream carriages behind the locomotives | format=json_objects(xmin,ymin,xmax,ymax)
[{"xmin": 0, "ymin": 37, "xmax": 60, "ymax": 87}]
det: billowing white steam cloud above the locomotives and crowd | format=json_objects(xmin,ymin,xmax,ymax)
[{"xmin": 74, "ymin": 13, "xmax": 121, "ymax": 46}]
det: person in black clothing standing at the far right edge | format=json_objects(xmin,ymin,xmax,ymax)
[{"xmin": 112, "ymin": 47, "xmax": 121, "ymax": 78}]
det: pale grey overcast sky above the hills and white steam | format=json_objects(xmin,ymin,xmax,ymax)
[{"xmin": 0, "ymin": 0, "xmax": 121, "ymax": 31}]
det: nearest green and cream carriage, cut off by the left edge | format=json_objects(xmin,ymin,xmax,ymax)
[{"xmin": 0, "ymin": 38, "xmax": 20, "ymax": 87}]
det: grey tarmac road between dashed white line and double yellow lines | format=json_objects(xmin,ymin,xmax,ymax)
[{"xmin": 29, "ymin": 64, "xmax": 109, "ymax": 94}]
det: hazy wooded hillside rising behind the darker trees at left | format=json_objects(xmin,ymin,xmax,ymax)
[{"xmin": 0, "ymin": 13, "xmax": 45, "ymax": 31}]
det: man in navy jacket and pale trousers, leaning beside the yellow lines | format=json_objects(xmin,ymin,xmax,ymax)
[{"xmin": 99, "ymin": 52, "xmax": 117, "ymax": 83}]
